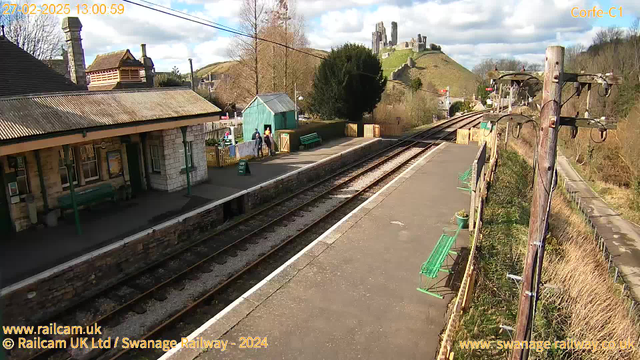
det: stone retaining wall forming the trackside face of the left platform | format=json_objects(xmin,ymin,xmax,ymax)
[{"xmin": 0, "ymin": 139, "xmax": 392, "ymax": 325}]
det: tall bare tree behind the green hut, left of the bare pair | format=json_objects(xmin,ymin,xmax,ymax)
[{"xmin": 230, "ymin": 0, "xmax": 266, "ymax": 96}]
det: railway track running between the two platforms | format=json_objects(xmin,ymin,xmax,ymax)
[{"xmin": 11, "ymin": 113, "xmax": 481, "ymax": 359}]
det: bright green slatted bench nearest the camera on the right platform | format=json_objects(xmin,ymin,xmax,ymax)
[{"xmin": 417, "ymin": 226, "xmax": 462, "ymax": 299}]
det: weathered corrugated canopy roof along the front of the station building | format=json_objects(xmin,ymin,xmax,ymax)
[{"xmin": 0, "ymin": 87, "xmax": 220, "ymax": 142}]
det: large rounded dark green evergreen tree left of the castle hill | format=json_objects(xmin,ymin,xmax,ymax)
[{"xmin": 310, "ymin": 44, "xmax": 387, "ymax": 121}]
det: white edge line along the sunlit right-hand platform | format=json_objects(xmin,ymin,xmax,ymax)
[{"xmin": 158, "ymin": 142, "xmax": 447, "ymax": 360}]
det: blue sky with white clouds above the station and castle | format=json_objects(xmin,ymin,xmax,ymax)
[{"xmin": 23, "ymin": 0, "xmax": 640, "ymax": 73}]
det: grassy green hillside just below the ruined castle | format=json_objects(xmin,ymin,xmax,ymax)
[{"xmin": 382, "ymin": 50, "xmax": 479, "ymax": 98}]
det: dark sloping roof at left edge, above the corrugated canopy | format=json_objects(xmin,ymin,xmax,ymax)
[{"xmin": 0, "ymin": 35, "xmax": 83, "ymax": 96}]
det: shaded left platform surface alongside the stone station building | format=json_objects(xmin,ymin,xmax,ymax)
[{"xmin": 0, "ymin": 138, "xmax": 372, "ymax": 289}]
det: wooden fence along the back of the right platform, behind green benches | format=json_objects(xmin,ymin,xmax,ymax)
[{"xmin": 438, "ymin": 130, "xmax": 498, "ymax": 360}]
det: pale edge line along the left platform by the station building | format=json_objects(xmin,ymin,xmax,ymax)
[{"xmin": 0, "ymin": 138, "xmax": 384, "ymax": 297}]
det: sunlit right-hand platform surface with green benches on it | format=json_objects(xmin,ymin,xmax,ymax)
[{"xmin": 162, "ymin": 143, "xmax": 478, "ymax": 360}]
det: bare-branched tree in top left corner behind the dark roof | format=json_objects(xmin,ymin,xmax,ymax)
[{"xmin": 0, "ymin": 0, "xmax": 64, "ymax": 60}]
